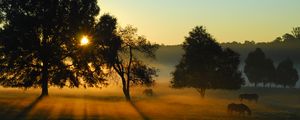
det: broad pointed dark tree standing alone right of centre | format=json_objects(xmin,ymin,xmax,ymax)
[{"xmin": 171, "ymin": 26, "xmax": 244, "ymax": 97}]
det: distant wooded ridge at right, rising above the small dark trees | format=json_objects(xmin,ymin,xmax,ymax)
[{"xmin": 222, "ymin": 27, "xmax": 300, "ymax": 65}]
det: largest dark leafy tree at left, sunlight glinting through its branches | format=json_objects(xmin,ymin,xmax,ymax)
[{"xmin": 0, "ymin": 0, "xmax": 103, "ymax": 96}]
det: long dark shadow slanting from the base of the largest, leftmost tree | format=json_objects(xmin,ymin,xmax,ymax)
[{"xmin": 15, "ymin": 96, "xmax": 44, "ymax": 120}]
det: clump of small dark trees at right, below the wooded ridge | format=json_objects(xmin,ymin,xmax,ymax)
[{"xmin": 244, "ymin": 48, "xmax": 299, "ymax": 88}]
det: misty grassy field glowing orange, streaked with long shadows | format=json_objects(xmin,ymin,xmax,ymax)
[{"xmin": 0, "ymin": 84, "xmax": 300, "ymax": 120}]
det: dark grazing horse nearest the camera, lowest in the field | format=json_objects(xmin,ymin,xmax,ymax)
[{"xmin": 227, "ymin": 103, "xmax": 251, "ymax": 116}]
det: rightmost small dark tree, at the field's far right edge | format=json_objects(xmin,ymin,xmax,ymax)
[{"xmin": 276, "ymin": 58, "xmax": 299, "ymax": 88}]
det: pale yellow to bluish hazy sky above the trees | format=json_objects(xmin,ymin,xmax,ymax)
[{"xmin": 99, "ymin": 0, "xmax": 300, "ymax": 44}]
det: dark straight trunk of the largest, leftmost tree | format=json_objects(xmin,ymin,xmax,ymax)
[{"xmin": 41, "ymin": 62, "xmax": 49, "ymax": 97}]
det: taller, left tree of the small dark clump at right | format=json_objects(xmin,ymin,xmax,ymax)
[{"xmin": 244, "ymin": 48, "xmax": 275, "ymax": 87}]
